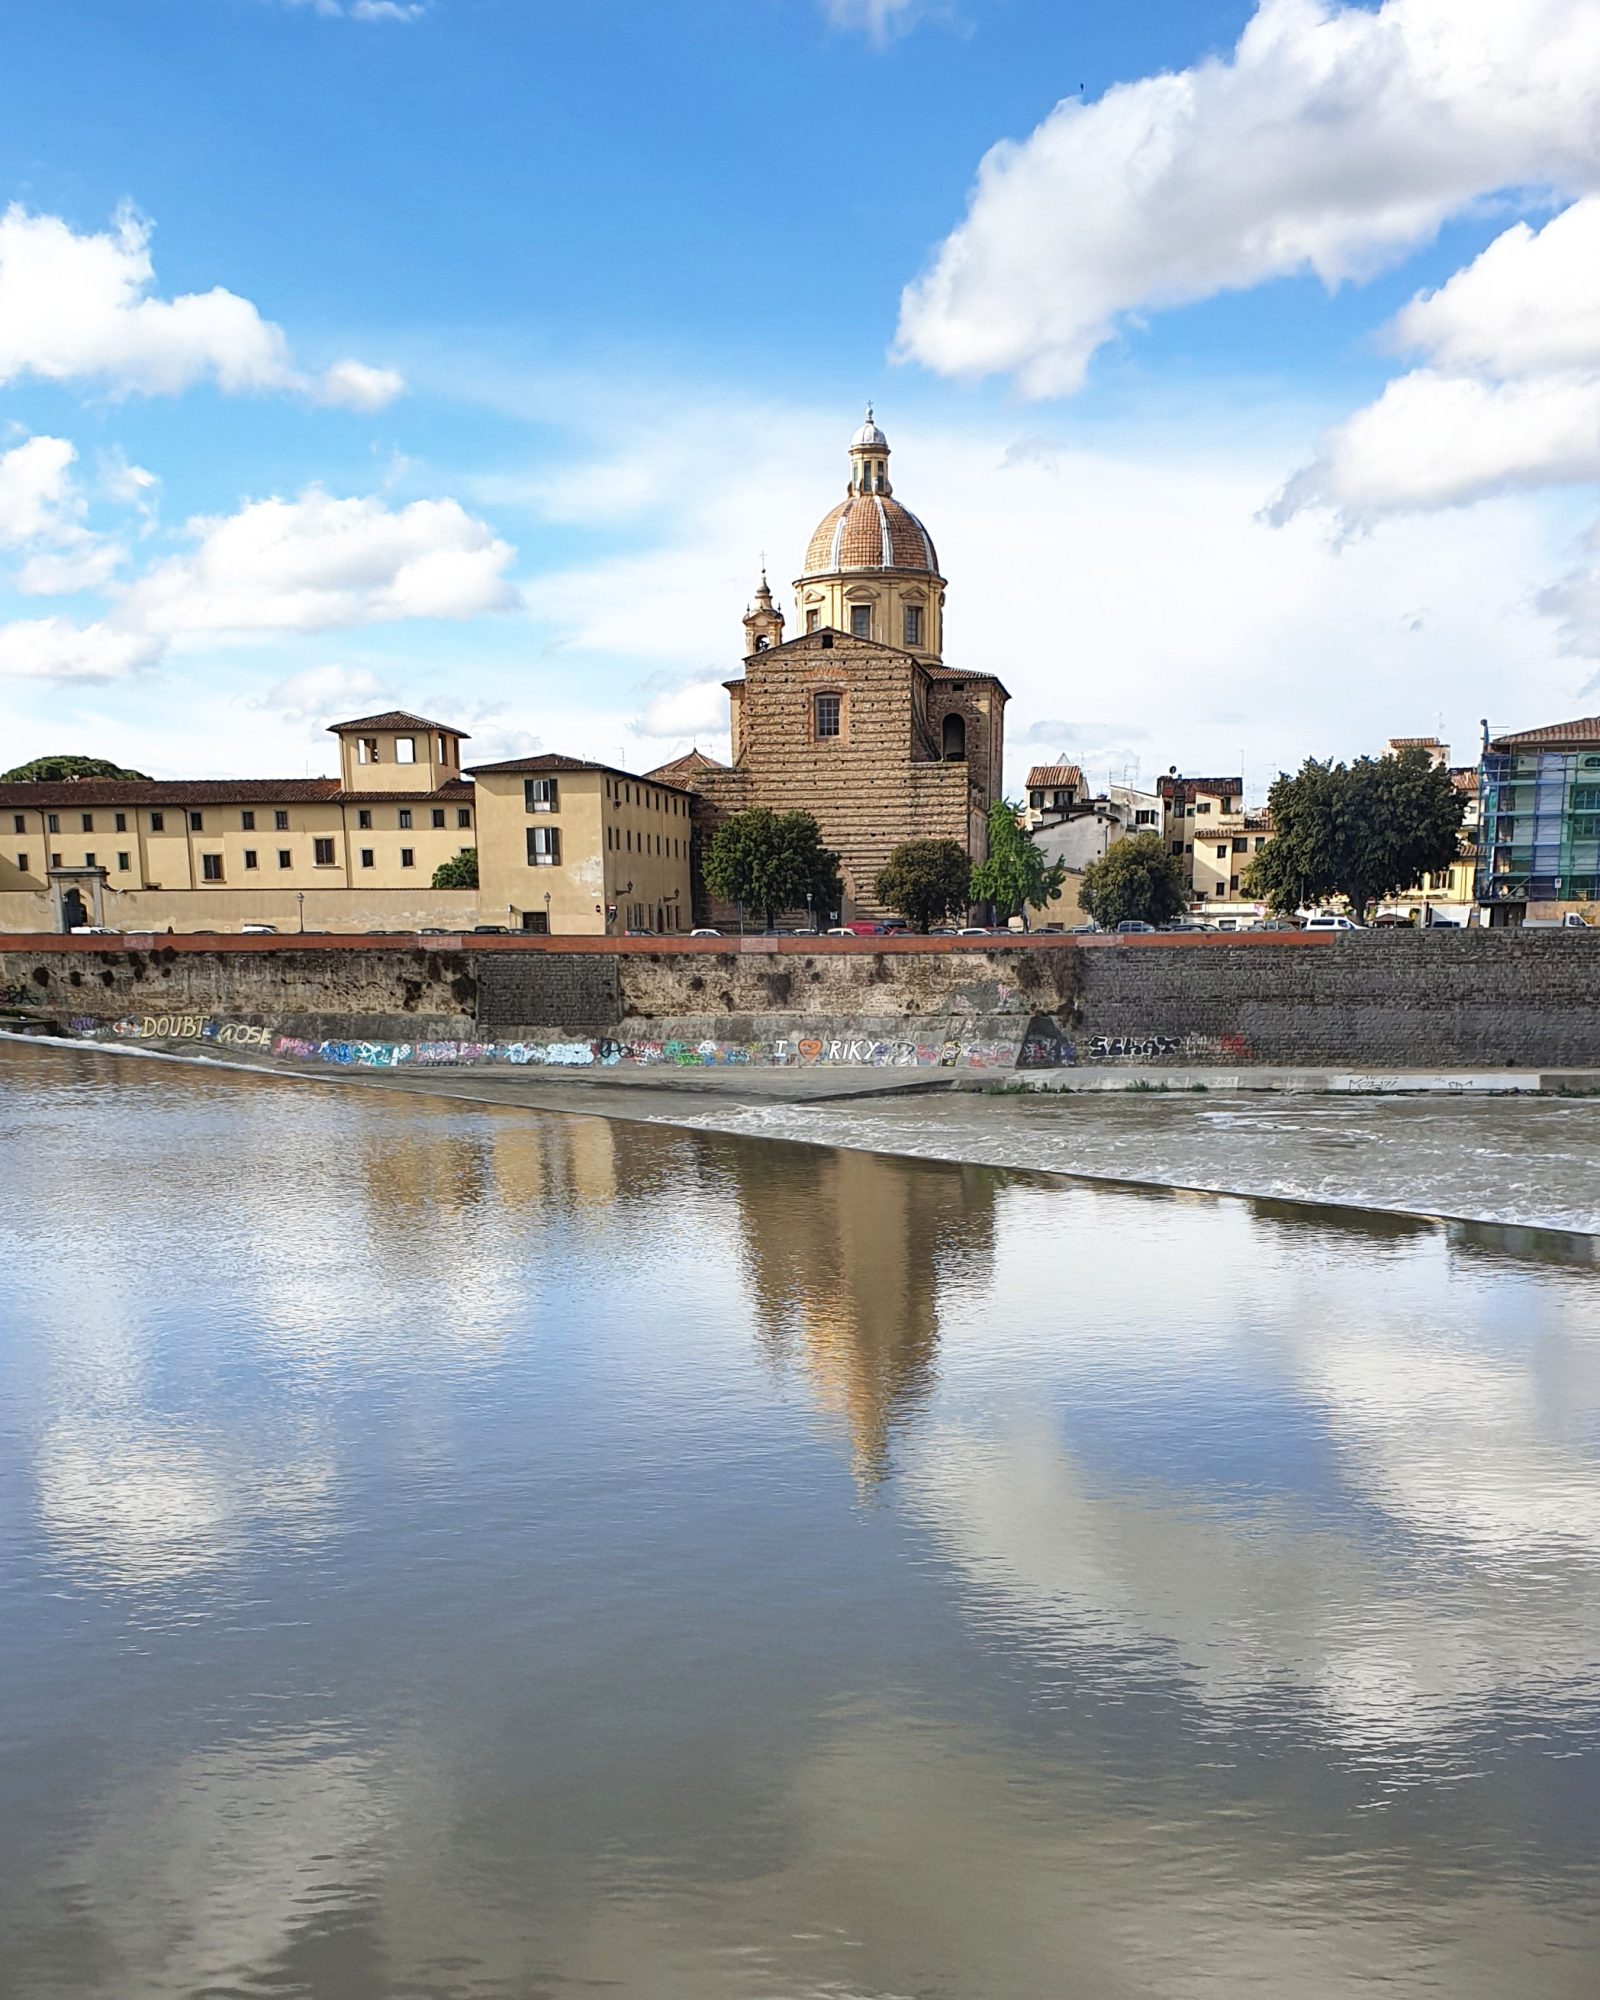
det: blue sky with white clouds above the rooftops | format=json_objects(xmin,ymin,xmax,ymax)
[{"xmin": 0, "ymin": 0, "xmax": 1600, "ymax": 798}]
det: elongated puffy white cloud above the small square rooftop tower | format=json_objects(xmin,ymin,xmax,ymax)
[{"xmin": 118, "ymin": 486, "xmax": 516, "ymax": 638}]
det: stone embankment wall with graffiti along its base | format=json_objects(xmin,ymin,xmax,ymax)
[{"xmin": 0, "ymin": 932, "xmax": 1600, "ymax": 1070}]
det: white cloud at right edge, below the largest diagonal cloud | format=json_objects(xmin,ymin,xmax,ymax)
[{"xmin": 1268, "ymin": 196, "xmax": 1600, "ymax": 524}]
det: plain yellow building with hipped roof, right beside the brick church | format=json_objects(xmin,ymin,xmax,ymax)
[{"xmin": 472, "ymin": 752, "xmax": 694, "ymax": 938}]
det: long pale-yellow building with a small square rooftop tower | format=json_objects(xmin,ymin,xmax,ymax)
[{"xmin": 0, "ymin": 710, "xmax": 476, "ymax": 930}]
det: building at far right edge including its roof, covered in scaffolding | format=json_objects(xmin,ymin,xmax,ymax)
[{"xmin": 1478, "ymin": 716, "xmax": 1600, "ymax": 926}]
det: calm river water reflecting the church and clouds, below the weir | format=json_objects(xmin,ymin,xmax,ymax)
[{"xmin": 0, "ymin": 1046, "xmax": 1600, "ymax": 2000}]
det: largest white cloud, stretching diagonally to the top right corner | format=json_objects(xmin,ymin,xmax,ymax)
[{"xmin": 900, "ymin": 0, "xmax": 1600, "ymax": 396}]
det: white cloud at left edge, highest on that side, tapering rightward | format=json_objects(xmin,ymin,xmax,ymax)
[{"xmin": 0, "ymin": 202, "xmax": 404, "ymax": 410}]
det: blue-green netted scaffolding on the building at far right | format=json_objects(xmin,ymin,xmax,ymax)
[{"xmin": 1478, "ymin": 750, "xmax": 1600, "ymax": 904}]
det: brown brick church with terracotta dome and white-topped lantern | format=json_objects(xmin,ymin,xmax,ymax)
[{"xmin": 648, "ymin": 418, "xmax": 1008, "ymax": 922}]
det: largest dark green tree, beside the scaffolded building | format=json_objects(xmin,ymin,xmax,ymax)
[{"xmin": 1246, "ymin": 750, "xmax": 1466, "ymax": 922}]
